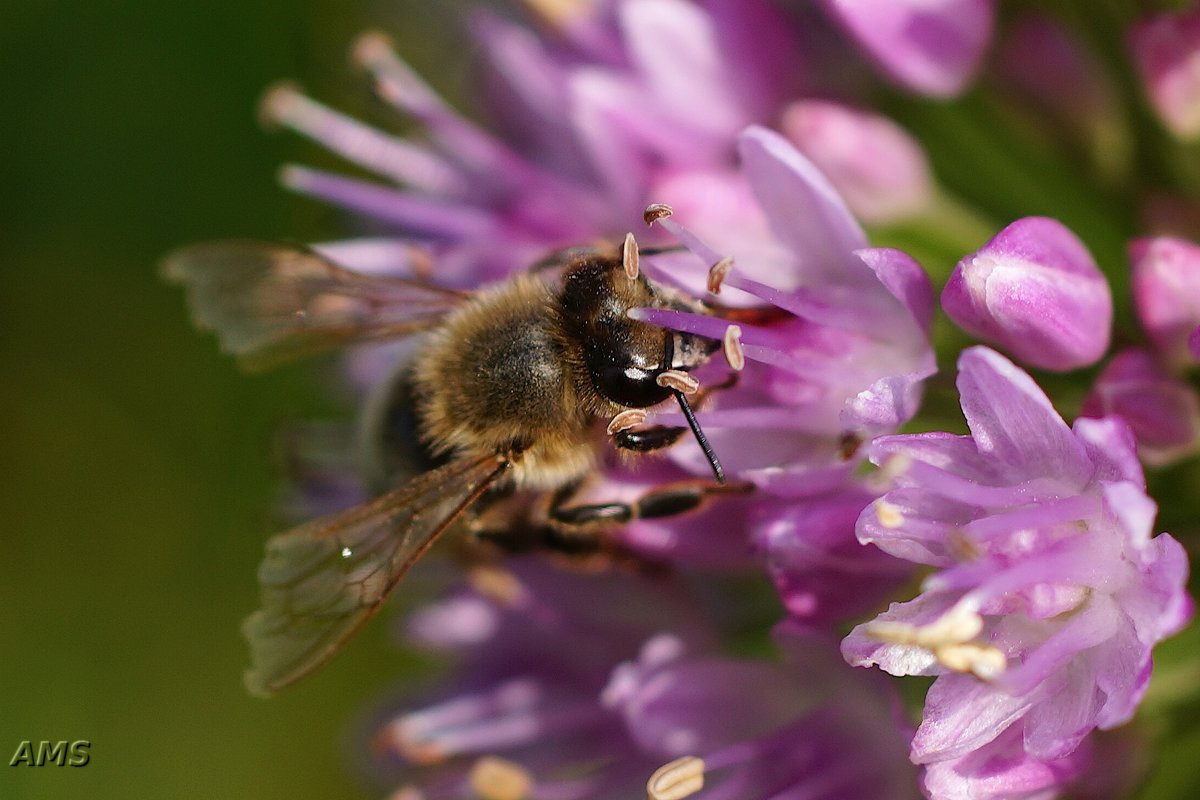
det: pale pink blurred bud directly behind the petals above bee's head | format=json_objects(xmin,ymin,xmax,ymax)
[{"xmin": 782, "ymin": 100, "xmax": 932, "ymax": 224}]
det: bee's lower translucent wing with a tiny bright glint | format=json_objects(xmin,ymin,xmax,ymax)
[{"xmin": 242, "ymin": 457, "xmax": 509, "ymax": 696}]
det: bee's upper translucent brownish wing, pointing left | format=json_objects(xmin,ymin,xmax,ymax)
[{"xmin": 162, "ymin": 241, "xmax": 467, "ymax": 369}]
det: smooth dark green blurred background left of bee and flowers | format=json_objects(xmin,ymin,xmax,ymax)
[{"xmin": 0, "ymin": 0, "xmax": 463, "ymax": 800}]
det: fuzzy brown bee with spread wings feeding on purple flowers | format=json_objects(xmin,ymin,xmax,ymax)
[{"xmin": 163, "ymin": 236, "xmax": 725, "ymax": 694}]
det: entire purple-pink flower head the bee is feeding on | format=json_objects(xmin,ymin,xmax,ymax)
[{"xmin": 175, "ymin": 0, "xmax": 1200, "ymax": 800}]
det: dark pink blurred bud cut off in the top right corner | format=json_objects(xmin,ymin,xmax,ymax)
[{"xmin": 1129, "ymin": 10, "xmax": 1200, "ymax": 138}]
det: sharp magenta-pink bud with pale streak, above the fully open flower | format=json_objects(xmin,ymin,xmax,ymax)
[{"xmin": 942, "ymin": 217, "xmax": 1112, "ymax": 371}]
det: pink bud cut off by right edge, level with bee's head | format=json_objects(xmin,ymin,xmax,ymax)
[{"xmin": 1129, "ymin": 236, "xmax": 1200, "ymax": 363}]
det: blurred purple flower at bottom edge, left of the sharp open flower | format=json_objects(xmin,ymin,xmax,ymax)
[{"xmin": 604, "ymin": 626, "xmax": 917, "ymax": 800}]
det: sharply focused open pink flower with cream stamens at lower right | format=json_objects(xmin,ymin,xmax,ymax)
[{"xmin": 842, "ymin": 348, "xmax": 1192, "ymax": 796}]
